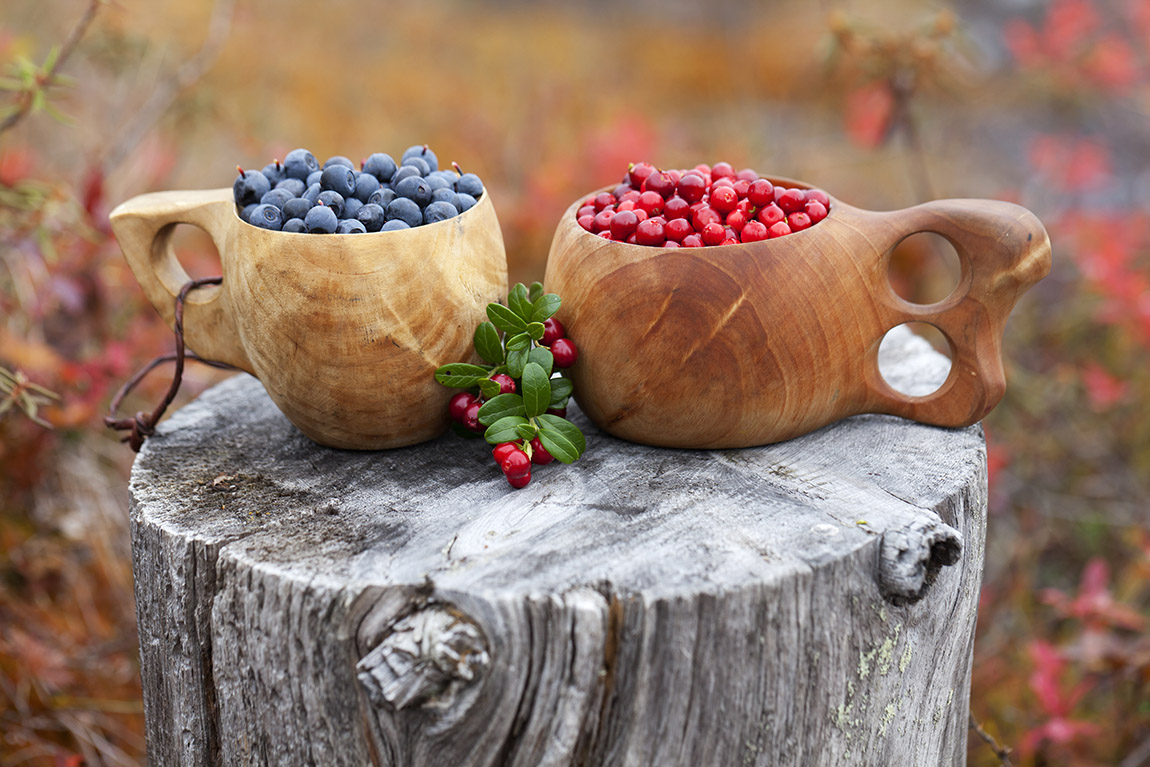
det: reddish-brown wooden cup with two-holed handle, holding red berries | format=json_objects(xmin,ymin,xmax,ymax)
[{"xmin": 544, "ymin": 179, "xmax": 1050, "ymax": 448}]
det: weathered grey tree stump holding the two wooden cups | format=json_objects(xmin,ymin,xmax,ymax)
[{"xmin": 131, "ymin": 329, "xmax": 987, "ymax": 767}]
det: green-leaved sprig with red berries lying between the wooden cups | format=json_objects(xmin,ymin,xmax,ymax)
[{"xmin": 435, "ymin": 283, "xmax": 587, "ymax": 488}]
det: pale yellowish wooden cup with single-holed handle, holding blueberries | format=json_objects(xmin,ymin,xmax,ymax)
[{"xmin": 112, "ymin": 189, "xmax": 507, "ymax": 450}]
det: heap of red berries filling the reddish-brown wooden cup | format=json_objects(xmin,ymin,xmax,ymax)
[{"xmin": 575, "ymin": 162, "xmax": 830, "ymax": 247}]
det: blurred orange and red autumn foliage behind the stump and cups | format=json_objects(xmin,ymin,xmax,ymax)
[{"xmin": 0, "ymin": 0, "xmax": 1150, "ymax": 767}]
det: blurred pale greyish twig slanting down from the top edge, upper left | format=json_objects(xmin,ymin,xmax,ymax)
[{"xmin": 97, "ymin": 0, "xmax": 236, "ymax": 176}]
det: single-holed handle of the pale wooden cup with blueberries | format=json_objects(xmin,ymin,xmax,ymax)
[{"xmin": 110, "ymin": 189, "xmax": 252, "ymax": 373}]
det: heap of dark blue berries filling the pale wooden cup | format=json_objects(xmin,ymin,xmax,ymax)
[{"xmin": 231, "ymin": 144, "xmax": 483, "ymax": 235}]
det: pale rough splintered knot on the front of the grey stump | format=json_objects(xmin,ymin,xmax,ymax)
[{"xmin": 355, "ymin": 605, "xmax": 491, "ymax": 711}]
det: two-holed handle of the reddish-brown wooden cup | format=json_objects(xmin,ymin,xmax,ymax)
[{"xmin": 866, "ymin": 200, "xmax": 1050, "ymax": 427}]
